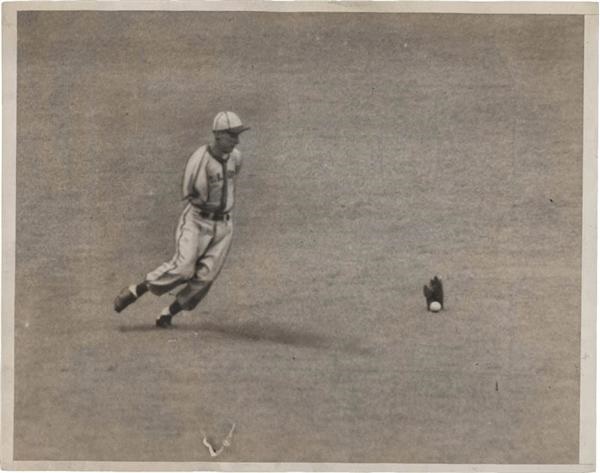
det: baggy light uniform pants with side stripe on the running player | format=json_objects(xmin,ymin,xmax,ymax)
[{"xmin": 146, "ymin": 204, "xmax": 233, "ymax": 310}]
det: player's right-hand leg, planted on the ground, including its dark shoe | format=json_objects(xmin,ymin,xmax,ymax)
[{"xmin": 156, "ymin": 222, "xmax": 233, "ymax": 326}]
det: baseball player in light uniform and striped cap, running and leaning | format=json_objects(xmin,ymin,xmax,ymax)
[{"xmin": 114, "ymin": 112, "xmax": 249, "ymax": 328}]
